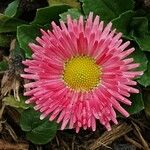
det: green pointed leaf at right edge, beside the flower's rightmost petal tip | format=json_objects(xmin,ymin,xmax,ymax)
[{"xmin": 137, "ymin": 61, "xmax": 150, "ymax": 87}]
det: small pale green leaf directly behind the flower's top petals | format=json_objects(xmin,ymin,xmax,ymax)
[{"xmin": 59, "ymin": 8, "xmax": 82, "ymax": 22}]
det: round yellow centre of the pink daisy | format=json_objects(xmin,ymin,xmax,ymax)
[{"xmin": 63, "ymin": 56, "xmax": 101, "ymax": 91}]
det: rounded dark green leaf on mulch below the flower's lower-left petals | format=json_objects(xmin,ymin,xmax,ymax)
[{"xmin": 20, "ymin": 109, "xmax": 57, "ymax": 144}]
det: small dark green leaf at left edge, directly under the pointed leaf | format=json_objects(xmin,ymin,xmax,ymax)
[{"xmin": 0, "ymin": 34, "xmax": 11, "ymax": 47}]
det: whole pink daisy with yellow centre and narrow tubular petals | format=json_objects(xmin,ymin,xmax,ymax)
[{"xmin": 21, "ymin": 13, "xmax": 143, "ymax": 132}]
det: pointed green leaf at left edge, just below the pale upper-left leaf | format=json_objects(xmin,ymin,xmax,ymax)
[{"xmin": 0, "ymin": 13, "xmax": 26, "ymax": 33}]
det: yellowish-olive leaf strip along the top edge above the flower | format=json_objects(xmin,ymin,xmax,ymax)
[{"xmin": 48, "ymin": 0, "xmax": 80, "ymax": 8}]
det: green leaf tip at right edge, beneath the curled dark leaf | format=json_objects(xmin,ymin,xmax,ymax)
[{"xmin": 133, "ymin": 33, "xmax": 150, "ymax": 51}]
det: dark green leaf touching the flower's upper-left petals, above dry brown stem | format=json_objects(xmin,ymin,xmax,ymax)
[{"xmin": 17, "ymin": 25, "xmax": 40, "ymax": 58}]
